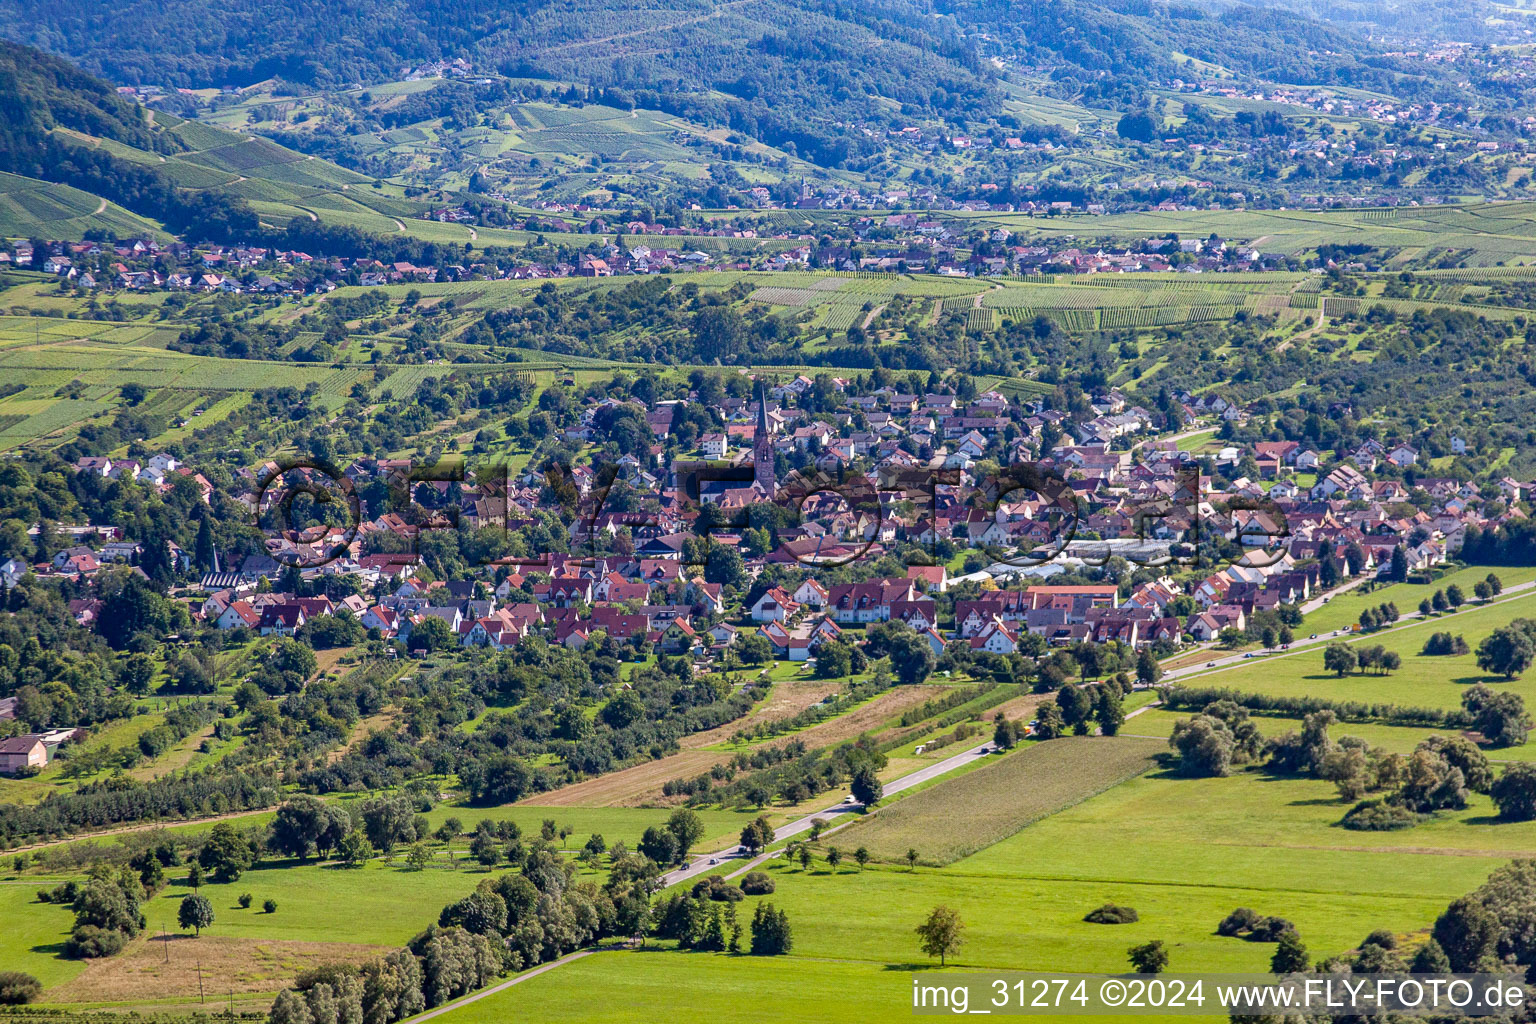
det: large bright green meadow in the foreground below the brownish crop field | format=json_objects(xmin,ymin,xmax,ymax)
[{"xmin": 436, "ymin": 764, "xmax": 1536, "ymax": 1024}]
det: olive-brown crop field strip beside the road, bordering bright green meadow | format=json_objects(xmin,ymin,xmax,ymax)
[{"xmin": 840, "ymin": 737, "xmax": 1166, "ymax": 866}]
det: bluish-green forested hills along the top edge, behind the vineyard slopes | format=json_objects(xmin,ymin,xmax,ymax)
[{"xmin": 0, "ymin": 0, "xmax": 1439, "ymax": 166}]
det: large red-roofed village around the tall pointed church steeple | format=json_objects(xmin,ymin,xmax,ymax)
[{"xmin": 0, "ymin": 368, "xmax": 1505, "ymax": 736}]
